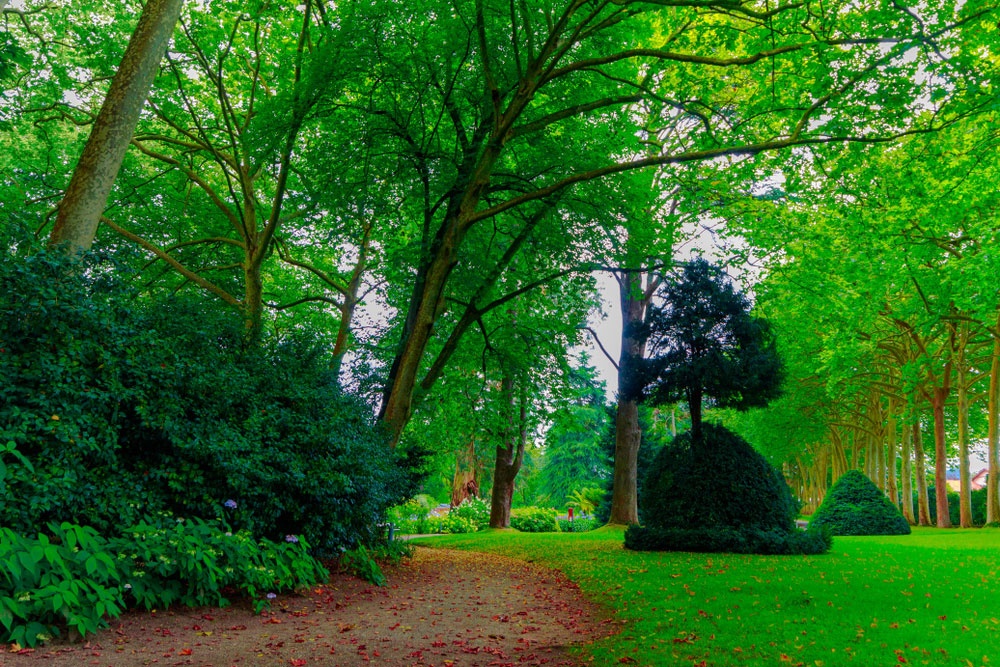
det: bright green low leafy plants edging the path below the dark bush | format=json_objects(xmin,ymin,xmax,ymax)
[{"xmin": 0, "ymin": 515, "xmax": 329, "ymax": 646}]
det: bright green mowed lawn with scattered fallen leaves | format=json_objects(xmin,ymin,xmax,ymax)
[{"xmin": 417, "ymin": 528, "xmax": 1000, "ymax": 667}]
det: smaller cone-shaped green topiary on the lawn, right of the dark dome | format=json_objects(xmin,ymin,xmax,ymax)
[{"xmin": 810, "ymin": 470, "xmax": 910, "ymax": 535}]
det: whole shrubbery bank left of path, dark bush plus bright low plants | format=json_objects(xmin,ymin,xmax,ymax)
[{"xmin": 0, "ymin": 251, "xmax": 418, "ymax": 646}]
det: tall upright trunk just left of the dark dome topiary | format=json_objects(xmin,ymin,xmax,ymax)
[{"xmin": 608, "ymin": 271, "xmax": 650, "ymax": 525}]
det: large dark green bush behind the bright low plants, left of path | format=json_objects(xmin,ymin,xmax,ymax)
[{"xmin": 0, "ymin": 251, "xmax": 413, "ymax": 555}]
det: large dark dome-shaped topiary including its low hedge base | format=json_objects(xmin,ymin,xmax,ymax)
[{"xmin": 625, "ymin": 424, "xmax": 830, "ymax": 554}]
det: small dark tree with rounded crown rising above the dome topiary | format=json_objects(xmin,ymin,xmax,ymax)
[{"xmin": 644, "ymin": 259, "xmax": 783, "ymax": 442}]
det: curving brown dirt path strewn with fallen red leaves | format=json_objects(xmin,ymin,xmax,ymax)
[{"xmin": 0, "ymin": 547, "xmax": 617, "ymax": 667}]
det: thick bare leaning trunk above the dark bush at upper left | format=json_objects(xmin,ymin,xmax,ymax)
[{"xmin": 49, "ymin": 0, "xmax": 184, "ymax": 253}]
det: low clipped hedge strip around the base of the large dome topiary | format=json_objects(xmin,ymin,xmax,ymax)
[{"xmin": 625, "ymin": 526, "xmax": 833, "ymax": 555}]
